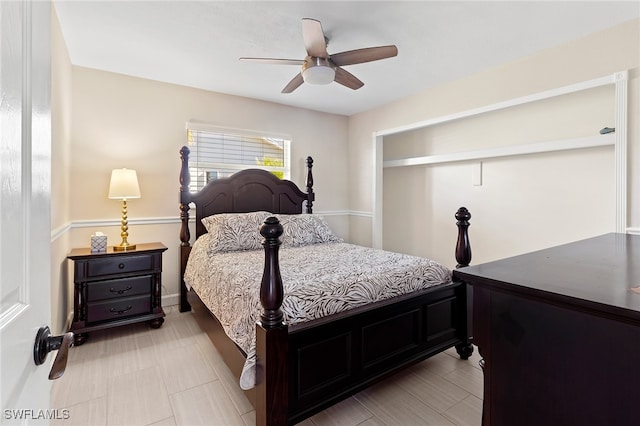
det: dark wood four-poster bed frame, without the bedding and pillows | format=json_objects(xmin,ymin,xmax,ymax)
[{"xmin": 180, "ymin": 147, "xmax": 473, "ymax": 425}]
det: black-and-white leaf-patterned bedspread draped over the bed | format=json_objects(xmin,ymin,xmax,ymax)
[{"xmin": 184, "ymin": 234, "xmax": 451, "ymax": 389}]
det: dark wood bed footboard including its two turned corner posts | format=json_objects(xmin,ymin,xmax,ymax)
[{"xmin": 256, "ymin": 207, "xmax": 473, "ymax": 425}]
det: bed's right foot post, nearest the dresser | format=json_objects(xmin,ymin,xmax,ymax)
[{"xmin": 456, "ymin": 207, "xmax": 473, "ymax": 359}]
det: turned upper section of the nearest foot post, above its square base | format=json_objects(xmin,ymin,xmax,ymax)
[{"xmin": 260, "ymin": 216, "xmax": 284, "ymax": 328}]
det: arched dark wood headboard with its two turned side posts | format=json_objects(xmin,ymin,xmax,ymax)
[{"xmin": 180, "ymin": 146, "xmax": 315, "ymax": 241}]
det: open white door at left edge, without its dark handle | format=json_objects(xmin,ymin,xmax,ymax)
[{"xmin": 0, "ymin": 0, "xmax": 55, "ymax": 424}]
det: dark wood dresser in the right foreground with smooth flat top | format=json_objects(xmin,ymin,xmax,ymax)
[{"xmin": 454, "ymin": 234, "xmax": 640, "ymax": 426}]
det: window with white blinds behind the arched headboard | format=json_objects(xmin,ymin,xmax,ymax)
[{"xmin": 187, "ymin": 122, "xmax": 290, "ymax": 192}]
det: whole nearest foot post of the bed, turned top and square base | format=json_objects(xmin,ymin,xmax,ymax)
[{"xmin": 256, "ymin": 217, "xmax": 289, "ymax": 426}]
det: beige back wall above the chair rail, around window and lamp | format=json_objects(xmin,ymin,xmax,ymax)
[{"xmin": 71, "ymin": 67, "xmax": 347, "ymax": 221}]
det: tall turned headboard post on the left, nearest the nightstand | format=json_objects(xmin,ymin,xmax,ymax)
[{"xmin": 180, "ymin": 146, "xmax": 191, "ymax": 312}]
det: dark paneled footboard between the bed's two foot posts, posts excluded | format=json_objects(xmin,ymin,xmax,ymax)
[{"xmin": 288, "ymin": 283, "xmax": 467, "ymax": 424}]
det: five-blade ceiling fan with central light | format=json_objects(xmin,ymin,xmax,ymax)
[{"xmin": 240, "ymin": 18, "xmax": 398, "ymax": 93}]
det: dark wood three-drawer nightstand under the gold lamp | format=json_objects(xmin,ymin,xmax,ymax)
[{"xmin": 67, "ymin": 243, "xmax": 167, "ymax": 346}]
